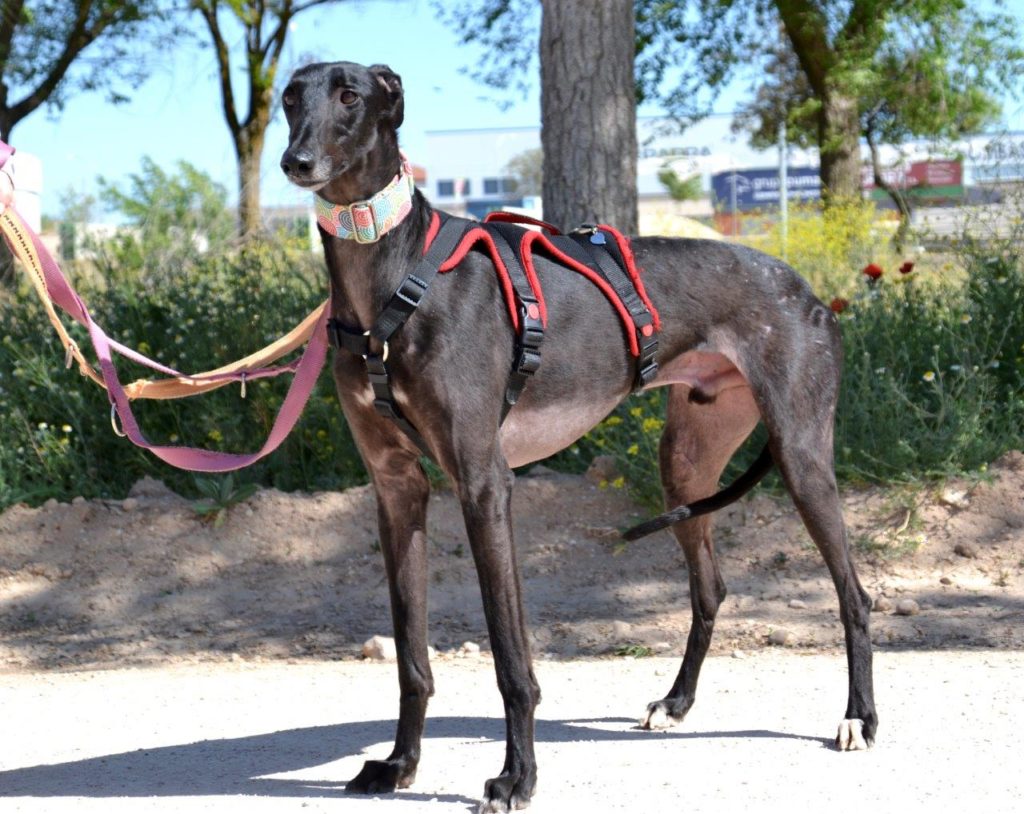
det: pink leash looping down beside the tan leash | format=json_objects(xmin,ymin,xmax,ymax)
[{"xmin": 0, "ymin": 141, "xmax": 331, "ymax": 472}]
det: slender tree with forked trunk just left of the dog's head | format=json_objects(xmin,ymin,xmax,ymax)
[{"xmin": 189, "ymin": 0, "xmax": 348, "ymax": 235}]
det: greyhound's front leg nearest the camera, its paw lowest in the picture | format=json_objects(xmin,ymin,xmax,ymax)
[{"xmin": 456, "ymin": 448, "xmax": 541, "ymax": 812}]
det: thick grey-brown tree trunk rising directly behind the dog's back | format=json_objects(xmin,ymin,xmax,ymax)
[{"xmin": 541, "ymin": 0, "xmax": 637, "ymax": 234}]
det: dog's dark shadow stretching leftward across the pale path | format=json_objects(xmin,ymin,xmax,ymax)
[{"xmin": 0, "ymin": 717, "xmax": 828, "ymax": 805}]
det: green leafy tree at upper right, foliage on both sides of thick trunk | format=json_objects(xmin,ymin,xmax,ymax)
[{"xmin": 450, "ymin": 0, "xmax": 1024, "ymax": 203}]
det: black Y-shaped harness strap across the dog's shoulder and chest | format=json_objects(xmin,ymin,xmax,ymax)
[{"xmin": 328, "ymin": 215, "xmax": 468, "ymax": 458}]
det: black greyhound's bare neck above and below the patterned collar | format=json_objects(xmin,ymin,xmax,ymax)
[{"xmin": 319, "ymin": 139, "xmax": 431, "ymax": 330}]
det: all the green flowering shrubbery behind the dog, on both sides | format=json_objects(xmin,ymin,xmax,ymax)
[{"xmin": 0, "ymin": 158, "xmax": 1024, "ymax": 507}]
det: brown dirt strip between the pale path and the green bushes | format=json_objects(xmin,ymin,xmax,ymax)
[{"xmin": 0, "ymin": 452, "xmax": 1024, "ymax": 673}]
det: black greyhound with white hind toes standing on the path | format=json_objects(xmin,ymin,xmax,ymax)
[{"xmin": 281, "ymin": 62, "xmax": 878, "ymax": 812}]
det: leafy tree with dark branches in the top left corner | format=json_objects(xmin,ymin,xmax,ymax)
[{"xmin": 0, "ymin": 0, "xmax": 165, "ymax": 141}]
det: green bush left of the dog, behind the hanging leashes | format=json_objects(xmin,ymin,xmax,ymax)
[{"xmin": 0, "ymin": 244, "xmax": 366, "ymax": 505}]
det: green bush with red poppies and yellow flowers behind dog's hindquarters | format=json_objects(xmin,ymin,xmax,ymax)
[{"xmin": 556, "ymin": 201, "xmax": 1024, "ymax": 510}]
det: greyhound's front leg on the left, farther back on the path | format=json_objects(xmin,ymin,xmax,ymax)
[{"xmin": 346, "ymin": 442, "xmax": 434, "ymax": 794}]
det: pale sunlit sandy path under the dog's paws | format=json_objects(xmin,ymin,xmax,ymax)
[{"xmin": 0, "ymin": 650, "xmax": 1024, "ymax": 814}]
